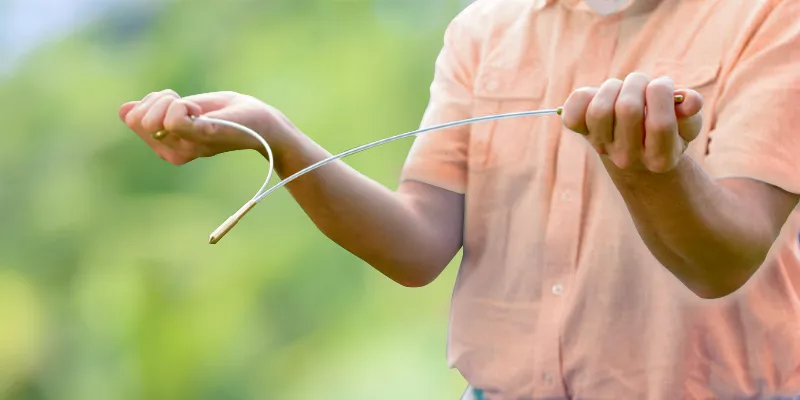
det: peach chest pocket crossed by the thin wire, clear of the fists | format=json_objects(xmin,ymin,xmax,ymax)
[{"xmin": 469, "ymin": 66, "xmax": 547, "ymax": 172}]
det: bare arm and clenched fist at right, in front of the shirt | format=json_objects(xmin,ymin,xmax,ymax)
[{"xmin": 564, "ymin": 73, "xmax": 798, "ymax": 298}]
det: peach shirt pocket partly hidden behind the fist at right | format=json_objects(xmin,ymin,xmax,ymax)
[{"xmin": 652, "ymin": 59, "xmax": 722, "ymax": 162}]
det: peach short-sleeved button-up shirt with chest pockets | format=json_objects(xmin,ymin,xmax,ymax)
[{"xmin": 402, "ymin": 0, "xmax": 800, "ymax": 400}]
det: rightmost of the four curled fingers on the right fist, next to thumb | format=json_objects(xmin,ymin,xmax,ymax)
[{"xmin": 642, "ymin": 78, "xmax": 686, "ymax": 173}]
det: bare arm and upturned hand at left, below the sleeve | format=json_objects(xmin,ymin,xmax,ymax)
[{"xmin": 119, "ymin": 90, "xmax": 464, "ymax": 287}]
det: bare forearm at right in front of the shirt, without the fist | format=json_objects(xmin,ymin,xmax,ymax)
[{"xmin": 607, "ymin": 156, "xmax": 788, "ymax": 297}]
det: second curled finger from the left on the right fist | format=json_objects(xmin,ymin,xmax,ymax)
[{"xmin": 586, "ymin": 79, "xmax": 623, "ymax": 154}]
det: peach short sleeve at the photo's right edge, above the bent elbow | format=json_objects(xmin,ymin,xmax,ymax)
[{"xmin": 705, "ymin": 0, "xmax": 800, "ymax": 194}]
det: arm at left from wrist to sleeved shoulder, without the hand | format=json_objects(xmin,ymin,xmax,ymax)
[{"xmin": 268, "ymin": 9, "xmax": 477, "ymax": 286}]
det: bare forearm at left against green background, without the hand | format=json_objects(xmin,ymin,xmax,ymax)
[{"xmin": 260, "ymin": 128, "xmax": 457, "ymax": 286}]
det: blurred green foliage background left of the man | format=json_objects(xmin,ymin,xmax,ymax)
[{"xmin": 0, "ymin": 0, "xmax": 472, "ymax": 400}]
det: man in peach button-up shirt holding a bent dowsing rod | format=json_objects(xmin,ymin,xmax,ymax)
[{"xmin": 120, "ymin": 0, "xmax": 800, "ymax": 400}]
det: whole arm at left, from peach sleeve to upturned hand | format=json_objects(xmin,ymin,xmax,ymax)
[{"xmin": 119, "ymin": 7, "xmax": 474, "ymax": 286}]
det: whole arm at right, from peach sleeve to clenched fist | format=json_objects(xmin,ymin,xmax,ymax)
[{"xmin": 563, "ymin": 1, "xmax": 800, "ymax": 298}]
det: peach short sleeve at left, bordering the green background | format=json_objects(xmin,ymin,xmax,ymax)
[{"xmin": 400, "ymin": 13, "xmax": 477, "ymax": 194}]
